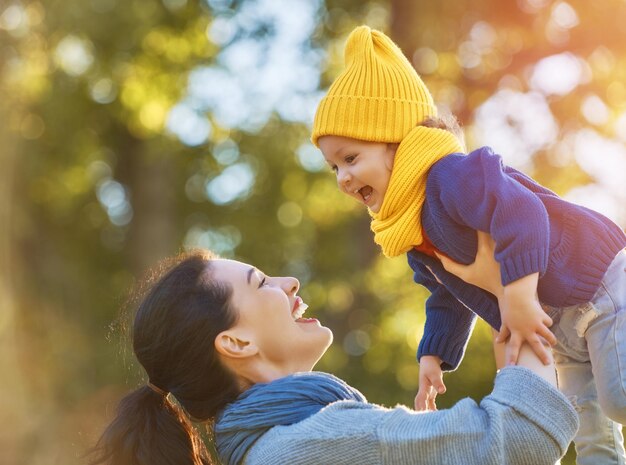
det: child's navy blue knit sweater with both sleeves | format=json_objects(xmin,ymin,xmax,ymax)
[{"xmin": 407, "ymin": 147, "xmax": 626, "ymax": 370}]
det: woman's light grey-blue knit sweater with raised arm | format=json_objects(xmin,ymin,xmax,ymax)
[{"xmin": 245, "ymin": 367, "xmax": 578, "ymax": 465}]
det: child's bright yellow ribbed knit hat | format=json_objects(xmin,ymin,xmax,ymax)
[{"xmin": 311, "ymin": 26, "xmax": 437, "ymax": 146}]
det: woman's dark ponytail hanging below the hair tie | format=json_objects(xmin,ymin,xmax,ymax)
[{"xmin": 90, "ymin": 386, "xmax": 211, "ymax": 465}]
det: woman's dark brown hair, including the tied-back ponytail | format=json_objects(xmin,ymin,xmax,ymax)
[{"xmin": 91, "ymin": 251, "xmax": 239, "ymax": 465}]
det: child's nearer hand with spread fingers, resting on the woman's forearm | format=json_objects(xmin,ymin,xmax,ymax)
[{"xmin": 496, "ymin": 273, "xmax": 556, "ymax": 365}]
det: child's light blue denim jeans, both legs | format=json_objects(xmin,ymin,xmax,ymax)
[{"xmin": 544, "ymin": 250, "xmax": 626, "ymax": 465}]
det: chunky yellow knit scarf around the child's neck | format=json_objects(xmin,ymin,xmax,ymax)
[{"xmin": 370, "ymin": 126, "xmax": 463, "ymax": 257}]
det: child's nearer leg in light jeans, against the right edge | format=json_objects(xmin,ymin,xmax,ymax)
[{"xmin": 578, "ymin": 251, "xmax": 626, "ymax": 424}]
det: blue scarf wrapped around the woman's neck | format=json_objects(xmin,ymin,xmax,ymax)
[{"xmin": 215, "ymin": 371, "xmax": 367, "ymax": 465}]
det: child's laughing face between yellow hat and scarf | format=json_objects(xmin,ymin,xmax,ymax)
[{"xmin": 318, "ymin": 136, "xmax": 398, "ymax": 213}]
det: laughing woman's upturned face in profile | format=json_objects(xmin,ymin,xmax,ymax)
[{"xmin": 211, "ymin": 259, "xmax": 333, "ymax": 375}]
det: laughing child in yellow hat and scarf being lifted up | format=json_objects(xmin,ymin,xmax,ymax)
[{"xmin": 311, "ymin": 26, "xmax": 626, "ymax": 463}]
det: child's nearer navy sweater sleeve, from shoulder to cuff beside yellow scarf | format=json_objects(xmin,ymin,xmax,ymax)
[{"xmin": 428, "ymin": 147, "xmax": 550, "ymax": 286}]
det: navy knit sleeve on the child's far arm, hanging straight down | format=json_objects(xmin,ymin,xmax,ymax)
[{"xmin": 414, "ymin": 264, "xmax": 476, "ymax": 371}]
